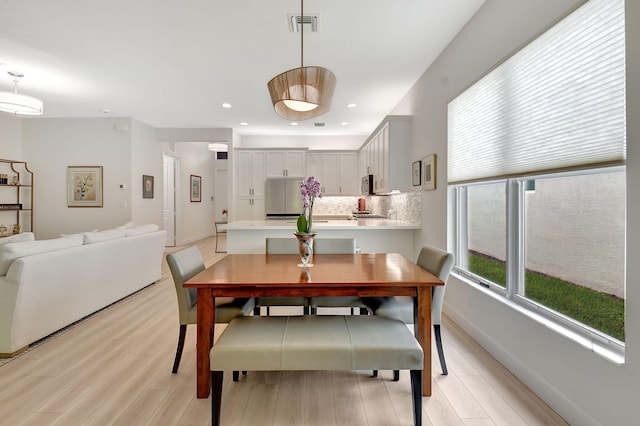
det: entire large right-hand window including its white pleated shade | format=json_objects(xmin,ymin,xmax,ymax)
[{"xmin": 448, "ymin": 0, "xmax": 626, "ymax": 352}]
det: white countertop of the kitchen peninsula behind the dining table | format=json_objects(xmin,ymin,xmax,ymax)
[{"xmin": 226, "ymin": 219, "xmax": 420, "ymax": 232}]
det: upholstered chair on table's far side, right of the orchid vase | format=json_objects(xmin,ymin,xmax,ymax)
[{"xmin": 309, "ymin": 238, "xmax": 368, "ymax": 315}]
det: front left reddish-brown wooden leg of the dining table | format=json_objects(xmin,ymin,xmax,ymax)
[{"xmin": 196, "ymin": 288, "xmax": 216, "ymax": 398}]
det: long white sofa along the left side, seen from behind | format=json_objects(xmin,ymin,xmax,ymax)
[{"xmin": 0, "ymin": 225, "xmax": 166, "ymax": 357}]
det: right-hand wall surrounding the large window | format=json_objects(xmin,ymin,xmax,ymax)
[{"xmin": 392, "ymin": 0, "xmax": 640, "ymax": 425}]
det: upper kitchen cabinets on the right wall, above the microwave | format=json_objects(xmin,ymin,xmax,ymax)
[{"xmin": 360, "ymin": 115, "xmax": 411, "ymax": 194}]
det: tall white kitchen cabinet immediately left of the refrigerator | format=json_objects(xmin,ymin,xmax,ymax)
[{"xmin": 233, "ymin": 150, "xmax": 266, "ymax": 220}]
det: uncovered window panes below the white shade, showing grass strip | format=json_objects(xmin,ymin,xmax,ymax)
[{"xmin": 453, "ymin": 167, "xmax": 626, "ymax": 344}]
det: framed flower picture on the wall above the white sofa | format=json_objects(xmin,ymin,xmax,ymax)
[{"xmin": 67, "ymin": 166, "xmax": 102, "ymax": 207}]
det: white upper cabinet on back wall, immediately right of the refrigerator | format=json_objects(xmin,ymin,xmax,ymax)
[{"xmin": 307, "ymin": 151, "xmax": 360, "ymax": 195}]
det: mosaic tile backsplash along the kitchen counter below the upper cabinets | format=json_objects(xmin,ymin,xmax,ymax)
[{"xmin": 313, "ymin": 192, "xmax": 422, "ymax": 223}]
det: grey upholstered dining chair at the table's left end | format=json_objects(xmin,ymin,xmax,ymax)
[{"xmin": 167, "ymin": 246, "xmax": 255, "ymax": 372}]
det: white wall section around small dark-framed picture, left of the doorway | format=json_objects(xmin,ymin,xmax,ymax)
[{"xmin": 130, "ymin": 120, "xmax": 167, "ymax": 227}]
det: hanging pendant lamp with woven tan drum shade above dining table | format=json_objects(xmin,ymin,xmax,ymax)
[{"xmin": 267, "ymin": 0, "xmax": 336, "ymax": 121}]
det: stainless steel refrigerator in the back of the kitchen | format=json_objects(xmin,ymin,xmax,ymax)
[{"xmin": 264, "ymin": 177, "xmax": 303, "ymax": 218}]
